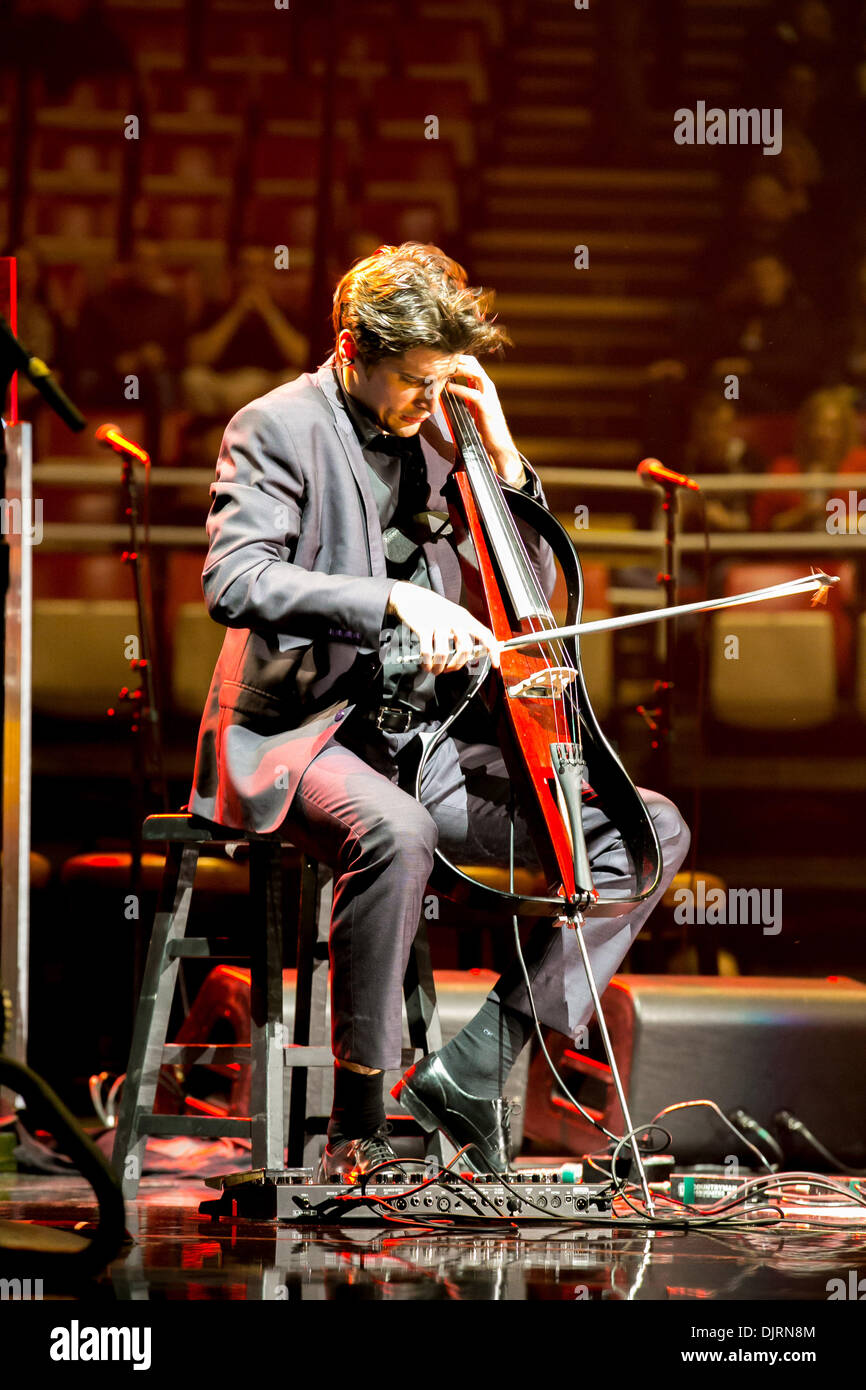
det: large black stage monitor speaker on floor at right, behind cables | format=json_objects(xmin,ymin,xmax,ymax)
[{"xmin": 524, "ymin": 974, "xmax": 866, "ymax": 1172}]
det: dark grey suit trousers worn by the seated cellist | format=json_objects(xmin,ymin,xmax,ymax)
[{"xmin": 284, "ymin": 719, "xmax": 689, "ymax": 1070}]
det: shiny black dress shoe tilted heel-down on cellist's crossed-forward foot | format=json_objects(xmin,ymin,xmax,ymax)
[{"xmin": 391, "ymin": 1052, "xmax": 516, "ymax": 1173}]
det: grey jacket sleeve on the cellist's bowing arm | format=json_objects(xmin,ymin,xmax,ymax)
[{"xmin": 202, "ymin": 402, "xmax": 393, "ymax": 648}]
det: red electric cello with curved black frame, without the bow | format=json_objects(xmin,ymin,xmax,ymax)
[{"xmin": 416, "ymin": 393, "xmax": 662, "ymax": 917}]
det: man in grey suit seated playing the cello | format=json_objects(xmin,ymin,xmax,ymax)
[{"xmin": 189, "ymin": 242, "xmax": 689, "ymax": 1182}]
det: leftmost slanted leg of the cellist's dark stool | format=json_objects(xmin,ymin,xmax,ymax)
[{"xmin": 111, "ymin": 844, "xmax": 199, "ymax": 1198}]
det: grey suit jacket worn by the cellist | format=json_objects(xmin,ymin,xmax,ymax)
[{"xmin": 189, "ymin": 364, "xmax": 553, "ymax": 833}]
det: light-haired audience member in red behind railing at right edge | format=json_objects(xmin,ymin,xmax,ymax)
[{"xmin": 753, "ymin": 386, "xmax": 866, "ymax": 531}]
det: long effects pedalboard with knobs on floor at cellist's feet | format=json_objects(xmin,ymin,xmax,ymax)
[{"xmin": 199, "ymin": 1168, "xmax": 610, "ymax": 1226}]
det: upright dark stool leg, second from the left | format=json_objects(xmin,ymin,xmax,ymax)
[{"xmin": 250, "ymin": 841, "xmax": 285, "ymax": 1169}]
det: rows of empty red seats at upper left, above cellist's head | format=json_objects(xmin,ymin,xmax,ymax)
[{"xmin": 16, "ymin": 0, "xmax": 492, "ymax": 268}]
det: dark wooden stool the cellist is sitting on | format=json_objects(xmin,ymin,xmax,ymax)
[{"xmin": 113, "ymin": 813, "xmax": 443, "ymax": 1197}]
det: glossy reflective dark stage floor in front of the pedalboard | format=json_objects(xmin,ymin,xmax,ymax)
[{"xmin": 0, "ymin": 1173, "xmax": 866, "ymax": 1301}]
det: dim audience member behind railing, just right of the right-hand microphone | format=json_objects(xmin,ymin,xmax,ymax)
[{"xmin": 680, "ymin": 403, "xmax": 767, "ymax": 531}]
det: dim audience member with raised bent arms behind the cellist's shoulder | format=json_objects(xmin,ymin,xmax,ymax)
[{"xmin": 183, "ymin": 246, "xmax": 307, "ymax": 416}]
